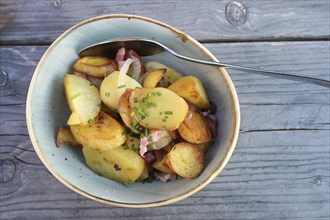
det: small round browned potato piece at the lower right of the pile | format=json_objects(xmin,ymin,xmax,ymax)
[{"xmin": 167, "ymin": 143, "xmax": 204, "ymax": 179}]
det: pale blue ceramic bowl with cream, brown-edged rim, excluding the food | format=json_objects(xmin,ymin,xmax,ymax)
[{"xmin": 26, "ymin": 14, "xmax": 240, "ymax": 208}]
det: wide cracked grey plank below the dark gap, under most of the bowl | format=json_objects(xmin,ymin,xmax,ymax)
[{"xmin": 0, "ymin": 42, "xmax": 330, "ymax": 220}]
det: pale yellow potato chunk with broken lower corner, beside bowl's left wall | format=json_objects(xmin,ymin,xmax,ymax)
[{"xmin": 64, "ymin": 74, "xmax": 101, "ymax": 125}]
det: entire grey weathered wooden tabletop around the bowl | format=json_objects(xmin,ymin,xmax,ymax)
[{"xmin": 0, "ymin": 0, "xmax": 330, "ymax": 220}]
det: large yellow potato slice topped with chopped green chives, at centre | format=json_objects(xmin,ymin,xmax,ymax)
[{"xmin": 129, "ymin": 88, "xmax": 188, "ymax": 130}]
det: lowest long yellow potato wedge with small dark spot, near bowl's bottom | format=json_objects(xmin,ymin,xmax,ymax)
[{"xmin": 83, "ymin": 146, "xmax": 145, "ymax": 184}]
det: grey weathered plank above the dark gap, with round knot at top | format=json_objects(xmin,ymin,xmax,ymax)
[{"xmin": 0, "ymin": 0, "xmax": 330, "ymax": 45}]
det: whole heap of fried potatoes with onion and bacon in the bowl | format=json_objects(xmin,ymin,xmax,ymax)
[{"xmin": 57, "ymin": 48, "xmax": 217, "ymax": 186}]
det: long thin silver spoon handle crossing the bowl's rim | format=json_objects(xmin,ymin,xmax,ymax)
[{"xmin": 167, "ymin": 48, "xmax": 330, "ymax": 88}]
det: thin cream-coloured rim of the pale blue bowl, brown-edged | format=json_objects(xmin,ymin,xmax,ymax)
[{"xmin": 26, "ymin": 14, "xmax": 241, "ymax": 208}]
